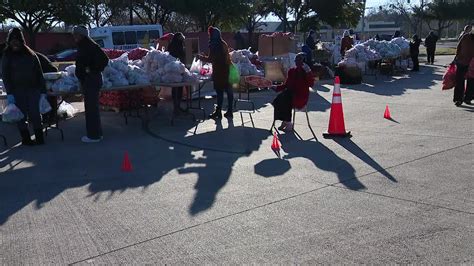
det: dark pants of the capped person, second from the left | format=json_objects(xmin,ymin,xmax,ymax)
[{"xmin": 81, "ymin": 73, "xmax": 102, "ymax": 139}]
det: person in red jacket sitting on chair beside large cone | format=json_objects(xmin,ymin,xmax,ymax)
[{"xmin": 272, "ymin": 53, "xmax": 314, "ymax": 131}]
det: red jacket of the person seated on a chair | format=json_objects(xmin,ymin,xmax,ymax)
[{"xmin": 277, "ymin": 67, "xmax": 314, "ymax": 109}]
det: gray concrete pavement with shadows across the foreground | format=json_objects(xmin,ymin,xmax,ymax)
[{"xmin": 0, "ymin": 57, "xmax": 474, "ymax": 265}]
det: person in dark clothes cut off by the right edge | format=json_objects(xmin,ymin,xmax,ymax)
[{"xmin": 453, "ymin": 32, "xmax": 474, "ymax": 106}]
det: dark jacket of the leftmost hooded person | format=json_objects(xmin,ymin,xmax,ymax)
[{"xmin": 2, "ymin": 50, "xmax": 46, "ymax": 94}]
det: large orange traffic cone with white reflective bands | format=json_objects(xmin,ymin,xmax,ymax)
[{"xmin": 323, "ymin": 76, "xmax": 351, "ymax": 138}]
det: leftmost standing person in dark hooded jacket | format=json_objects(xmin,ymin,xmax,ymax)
[{"xmin": 2, "ymin": 28, "xmax": 46, "ymax": 146}]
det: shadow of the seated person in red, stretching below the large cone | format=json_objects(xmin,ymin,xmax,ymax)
[{"xmin": 280, "ymin": 134, "xmax": 366, "ymax": 190}]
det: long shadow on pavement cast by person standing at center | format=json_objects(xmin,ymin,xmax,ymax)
[{"xmin": 178, "ymin": 127, "xmax": 268, "ymax": 216}]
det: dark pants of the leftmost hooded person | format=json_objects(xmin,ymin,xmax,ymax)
[{"xmin": 13, "ymin": 91, "xmax": 42, "ymax": 131}]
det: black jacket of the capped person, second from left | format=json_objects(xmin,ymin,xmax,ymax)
[{"xmin": 76, "ymin": 37, "xmax": 108, "ymax": 82}]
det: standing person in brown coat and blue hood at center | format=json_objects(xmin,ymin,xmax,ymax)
[{"xmin": 199, "ymin": 27, "xmax": 234, "ymax": 119}]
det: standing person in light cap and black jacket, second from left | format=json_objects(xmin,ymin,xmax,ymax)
[{"xmin": 72, "ymin": 26, "xmax": 109, "ymax": 143}]
